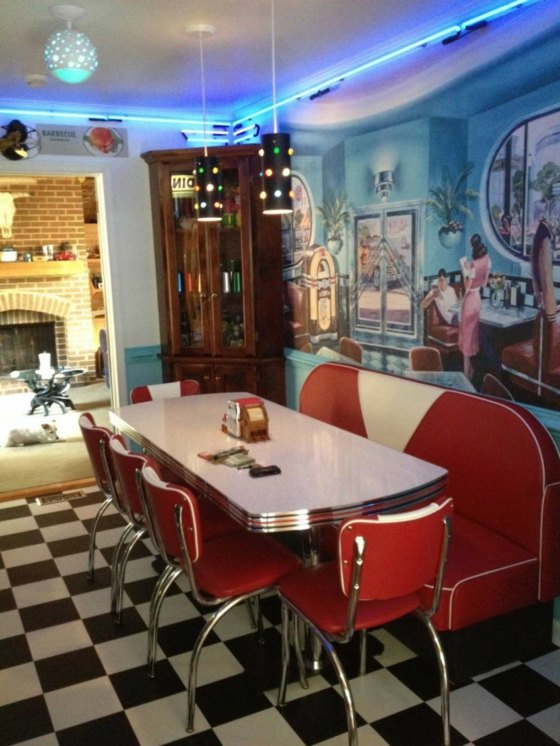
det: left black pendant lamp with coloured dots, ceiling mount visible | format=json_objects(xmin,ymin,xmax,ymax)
[{"xmin": 187, "ymin": 24, "xmax": 223, "ymax": 223}]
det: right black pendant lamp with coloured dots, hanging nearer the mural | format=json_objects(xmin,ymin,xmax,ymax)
[{"xmin": 259, "ymin": 0, "xmax": 294, "ymax": 215}]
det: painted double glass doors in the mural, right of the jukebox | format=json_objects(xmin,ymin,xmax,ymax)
[{"xmin": 355, "ymin": 209, "xmax": 417, "ymax": 334}]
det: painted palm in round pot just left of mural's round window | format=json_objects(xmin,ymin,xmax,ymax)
[{"xmin": 425, "ymin": 163, "xmax": 478, "ymax": 249}]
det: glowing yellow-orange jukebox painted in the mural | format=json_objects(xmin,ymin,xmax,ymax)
[{"xmin": 302, "ymin": 244, "xmax": 338, "ymax": 344}]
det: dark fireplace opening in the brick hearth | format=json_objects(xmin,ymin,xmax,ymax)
[{"xmin": 0, "ymin": 321, "xmax": 57, "ymax": 375}]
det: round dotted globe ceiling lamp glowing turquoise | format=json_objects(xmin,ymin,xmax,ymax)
[{"xmin": 45, "ymin": 5, "xmax": 97, "ymax": 83}]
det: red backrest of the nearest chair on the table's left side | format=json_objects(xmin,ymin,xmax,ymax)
[{"xmin": 142, "ymin": 460, "xmax": 202, "ymax": 564}]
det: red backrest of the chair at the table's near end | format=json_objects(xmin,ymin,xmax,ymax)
[{"xmin": 338, "ymin": 498, "xmax": 453, "ymax": 601}]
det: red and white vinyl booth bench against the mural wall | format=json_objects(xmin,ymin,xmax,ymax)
[{"xmin": 300, "ymin": 363, "xmax": 560, "ymax": 679}]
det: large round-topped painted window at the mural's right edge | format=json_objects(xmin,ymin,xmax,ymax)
[{"xmin": 487, "ymin": 103, "xmax": 560, "ymax": 264}]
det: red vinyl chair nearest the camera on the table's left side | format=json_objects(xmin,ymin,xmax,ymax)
[{"xmin": 142, "ymin": 464, "xmax": 300, "ymax": 733}]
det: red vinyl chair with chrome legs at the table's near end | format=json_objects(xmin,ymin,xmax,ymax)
[{"xmin": 278, "ymin": 498, "xmax": 453, "ymax": 746}]
